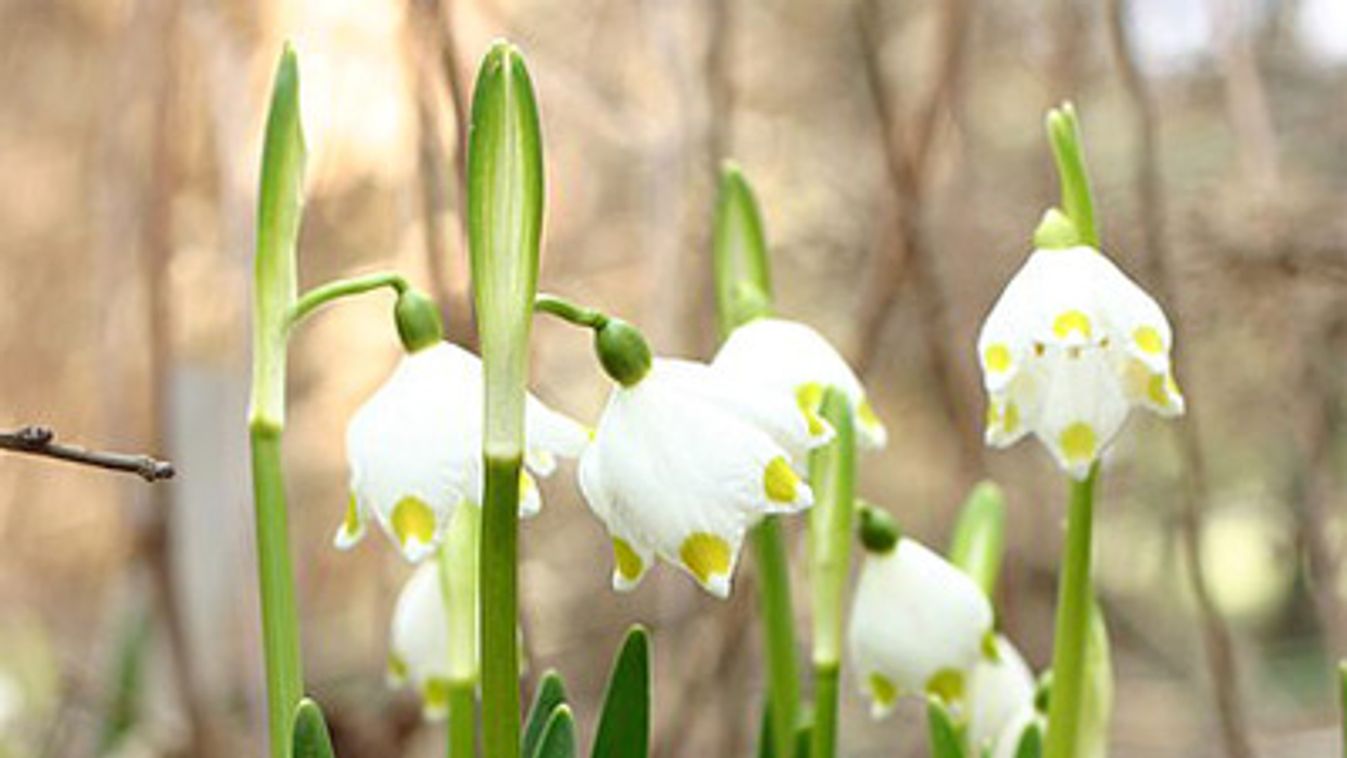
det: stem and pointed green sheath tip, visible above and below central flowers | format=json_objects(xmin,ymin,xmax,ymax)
[{"xmin": 713, "ymin": 163, "xmax": 800, "ymax": 758}]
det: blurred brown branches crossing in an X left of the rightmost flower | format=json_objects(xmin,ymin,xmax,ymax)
[{"xmin": 855, "ymin": 0, "xmax": 982, "ymax": 479}]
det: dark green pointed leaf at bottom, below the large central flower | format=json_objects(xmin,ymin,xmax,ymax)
[{"xmin": 590, "ymin": 626, "xmax": 651, "ymax": 758}]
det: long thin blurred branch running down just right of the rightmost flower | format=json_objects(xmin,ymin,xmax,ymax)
[{"xmin": 1106, "ymin": 0, "xmax": 1254, "ymax": 758}]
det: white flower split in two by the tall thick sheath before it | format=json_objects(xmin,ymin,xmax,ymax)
[{"xmin": 334, "ymin": 342, "xmax": 589, "ymax": 561}]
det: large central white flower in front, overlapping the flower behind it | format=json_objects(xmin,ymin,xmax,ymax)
[{"xmin": 579, "ymin": 358, "xmax": 826, "ymax": 598}]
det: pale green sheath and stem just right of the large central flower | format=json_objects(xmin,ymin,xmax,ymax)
[{"xmin": 810, "ymin": 388, "xmax": 855, "ymax": 758}]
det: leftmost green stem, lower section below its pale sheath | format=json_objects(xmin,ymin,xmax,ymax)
[{"xmin": 249, "ymin": 421, "xmax": 304, "ymax": 758}]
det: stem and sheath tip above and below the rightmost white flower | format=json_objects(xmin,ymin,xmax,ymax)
[{"xmin": 1036, "ymin": 104, "xmax": 1099, "ymax": 758}]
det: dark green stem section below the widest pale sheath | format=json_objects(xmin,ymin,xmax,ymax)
[{"xmin": 480, "ymin": 455, "xmax": 521, "ymax": 758}]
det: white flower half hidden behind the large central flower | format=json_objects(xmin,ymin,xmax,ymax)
[{"xmin": 711, "ymin": 318, "xmax": 889, "ymax": 450}]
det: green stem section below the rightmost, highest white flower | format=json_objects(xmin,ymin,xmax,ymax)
[{"xmin": 1044, "ymin": 463, "xmax": 1099, "ymax": 758}]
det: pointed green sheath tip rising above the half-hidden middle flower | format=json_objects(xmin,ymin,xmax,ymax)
[{"xmin": 713, "ymin": 162, "xmax": 772, "ymax": 337}]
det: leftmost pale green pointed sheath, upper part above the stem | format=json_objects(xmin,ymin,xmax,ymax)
[{"xmin": 248, "ymin": 44, "xmax": 304, "ymax": 429}]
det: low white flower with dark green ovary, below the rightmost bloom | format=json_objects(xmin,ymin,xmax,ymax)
[{"xmin": 850, "ymin": 537, "xmax": 991, "ymax": 718}]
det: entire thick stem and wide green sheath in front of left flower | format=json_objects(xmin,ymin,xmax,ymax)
[{"xmin": 467, "ymin": 42, "xmax": 543, "ymax": 758}]
